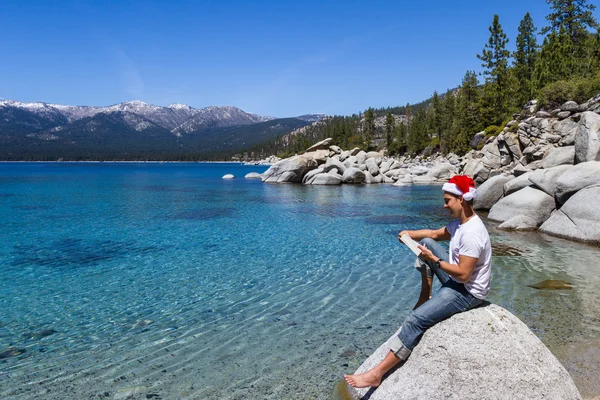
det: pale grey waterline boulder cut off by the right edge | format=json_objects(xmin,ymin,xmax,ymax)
[{"xmin": 540, "ymin": 186, "xmax": 600, "ymax": 244}]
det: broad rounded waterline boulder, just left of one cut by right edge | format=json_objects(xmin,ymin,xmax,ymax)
[{"xmin": 488, "ymin": 187, "xmax": 555, "ymax": 226}]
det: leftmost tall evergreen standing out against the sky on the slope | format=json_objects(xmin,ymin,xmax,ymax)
[{"xmin": 477, "ymin": 14, "xmax": 510, "ymax": 124}]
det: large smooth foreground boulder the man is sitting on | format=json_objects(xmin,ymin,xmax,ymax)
[{"xmin": 344, "ymin": 304, "xmax": 581, "ymax": 400}]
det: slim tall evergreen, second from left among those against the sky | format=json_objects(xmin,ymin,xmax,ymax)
[{"xmin": 513, "ymin": 13, "xmax": 538, "ymax": 107}]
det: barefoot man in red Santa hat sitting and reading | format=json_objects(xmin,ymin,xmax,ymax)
[{"xmin": 344, "ymin": 175, "xmax": 492, "ymax": 388}]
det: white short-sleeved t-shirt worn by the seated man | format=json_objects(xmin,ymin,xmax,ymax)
[{"xmin": 446, "ymin": 214, "xmax": 492, "ymax": 299}]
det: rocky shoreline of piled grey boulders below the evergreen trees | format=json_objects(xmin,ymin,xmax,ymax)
[{"xmin": 248, "ymin": 94, "xmax": 600, "ymax": 245}]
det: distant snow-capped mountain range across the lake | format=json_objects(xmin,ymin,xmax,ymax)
[{"xmin": 0, "ymin": 100, "xmax": 325, "ymax": 160}]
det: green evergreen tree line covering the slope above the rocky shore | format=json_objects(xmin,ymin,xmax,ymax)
[{"xmin": 251, "ymin": 0, "xmax": 600, "ymax": 156}]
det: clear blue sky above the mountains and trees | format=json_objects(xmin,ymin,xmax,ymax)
[{"xmin": 0, "ymin": 0, "xmax": 600, "ymax": 117}]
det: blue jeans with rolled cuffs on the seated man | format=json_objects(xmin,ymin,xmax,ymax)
[{"xmin": 390, "ymin": 239, "xmax": 483, "ymax": 360}]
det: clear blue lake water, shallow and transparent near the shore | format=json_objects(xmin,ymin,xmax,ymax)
[{"xmin": 0, "ymin": 163, "xmax": 600, "ymax": 399}]
